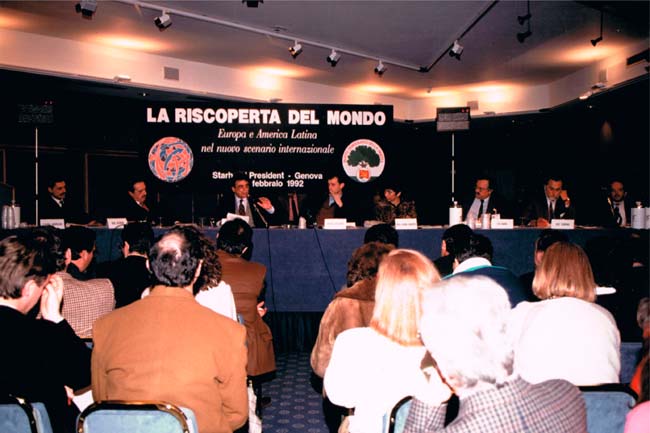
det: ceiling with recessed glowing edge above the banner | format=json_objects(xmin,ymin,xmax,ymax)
[{"xmin": 0, "ymin": 0, "xmax": 649, "ymax": 99}]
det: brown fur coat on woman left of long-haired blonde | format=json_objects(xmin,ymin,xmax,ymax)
[{"xmin": 311, "ymin": 278, "xmax": 376, "ymax": 377}]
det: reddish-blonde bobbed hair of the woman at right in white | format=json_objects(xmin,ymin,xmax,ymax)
[{"xmin": 533, "ymin": 242, "xmax": 596, "ymax": 302}]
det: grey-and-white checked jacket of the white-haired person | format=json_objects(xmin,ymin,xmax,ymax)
[{"xmin": 404, "ymin": 377, "xmax": 587, "ymax": 433}]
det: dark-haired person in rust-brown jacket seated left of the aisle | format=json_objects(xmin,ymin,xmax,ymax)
[{"xmin": 217, "ymin": 219, "xmax": 275, "ymax": 410}]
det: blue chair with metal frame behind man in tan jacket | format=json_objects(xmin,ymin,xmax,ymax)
[{"xmin": 77, "ymin": 400, "xmax": 198, "ymax": 433}]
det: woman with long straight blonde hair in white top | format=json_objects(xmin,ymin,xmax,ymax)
[{"xmin": 324, "ymin": 249, "xmax": 448, "ymax": 433}]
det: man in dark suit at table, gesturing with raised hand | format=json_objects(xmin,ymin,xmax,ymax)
[{"xmin": 217, "ymin": 173, "xmax": 282, "ymax": 228}]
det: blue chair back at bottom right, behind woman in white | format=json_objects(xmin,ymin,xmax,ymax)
[{"xmin": 579, "ymin": 383, "xmax": 636, "ymax": 433}]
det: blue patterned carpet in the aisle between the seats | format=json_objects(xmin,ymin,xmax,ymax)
[{"xmin": 262, "ymin": 352, "xmax": 328, "ymax": 433}]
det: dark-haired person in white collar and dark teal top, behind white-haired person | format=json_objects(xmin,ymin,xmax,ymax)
[{"xmin": 445, "ymin": 233, "xmax": 528, "ymax": 307}]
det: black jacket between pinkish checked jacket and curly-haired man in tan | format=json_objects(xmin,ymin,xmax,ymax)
[{"xmin": 97, "ymin": 256, "xmax": 152, "ymax": 308}]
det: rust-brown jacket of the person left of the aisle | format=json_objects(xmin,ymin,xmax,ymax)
[{"xmin": 217, "ymin": 250, "xmax": 275, "ymax": 376}]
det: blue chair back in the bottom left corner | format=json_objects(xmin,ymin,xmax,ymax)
[{"xmin": 0, "ymin": 395, "xmax": 52, "ymax": 433}]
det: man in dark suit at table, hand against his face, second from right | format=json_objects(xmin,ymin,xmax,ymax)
[{"xmin": 522, "ymin": 175, "xmax": 575, "ymax": 228}]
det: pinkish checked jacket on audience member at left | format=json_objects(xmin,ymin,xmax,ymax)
[{"xmin": 57, "ymin": 272, "xmax": 115, "ymax": 338}]
